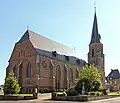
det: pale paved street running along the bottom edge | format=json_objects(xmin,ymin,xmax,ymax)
[{"xmin": 0, "ymin": 97, "xmax": 120, "ymax": 103}]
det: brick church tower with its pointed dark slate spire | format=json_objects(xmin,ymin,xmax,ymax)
[{"xmin": 88, "ymin": 11, "xmax": 105, "ymax": 86}]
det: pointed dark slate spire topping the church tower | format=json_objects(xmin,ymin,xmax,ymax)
[{"xmin": 90, "ymin": 3, "xmax": 101, "ymax": 44}]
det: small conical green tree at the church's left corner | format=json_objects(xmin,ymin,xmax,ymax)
[{"xmin": 4, "ymin": 73, "xmax": 21, "ymax": 94}]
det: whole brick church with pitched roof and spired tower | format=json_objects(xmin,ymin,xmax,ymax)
[{"xmin": 6, "ymin": 11, "xmax": 105, "ymax": 93}]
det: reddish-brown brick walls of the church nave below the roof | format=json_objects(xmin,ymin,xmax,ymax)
[{"xmin": 7, "ymin": 40, "xmax": 82, "ymax": 92}]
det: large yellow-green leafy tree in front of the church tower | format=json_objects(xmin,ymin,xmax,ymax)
[{"xmin": 75, "ymin": 65, "xmax": 103, "ymax": 93}]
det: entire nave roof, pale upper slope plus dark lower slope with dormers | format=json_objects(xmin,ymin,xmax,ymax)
[{"xmin": 19, "ymin": 30, "xmax": 86, "ymax": 66}]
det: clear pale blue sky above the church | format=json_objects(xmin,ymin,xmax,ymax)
[{"xmin": 0, "ymin": 0, "xmax": 120, "ymax": 84}]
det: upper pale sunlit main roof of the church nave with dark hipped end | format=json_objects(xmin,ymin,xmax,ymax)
[{"xmin": 19, "ymin": 30, "xmax": 74, "ymax": 55}]
